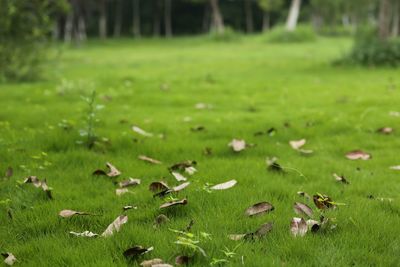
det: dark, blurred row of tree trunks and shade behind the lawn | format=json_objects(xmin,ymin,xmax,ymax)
[{"xmin": 54, "ymin": 0, "xmax": 311, "ymax": 41}]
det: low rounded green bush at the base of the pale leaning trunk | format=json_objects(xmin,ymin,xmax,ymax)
[{"xmin": 266, "ymin": 25, "xmax": 317, "ymax": 43}]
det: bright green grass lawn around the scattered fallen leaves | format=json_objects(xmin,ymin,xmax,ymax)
[{"xmin": 0, "ymin": 37, "xmax": 400, "ymax": 266}]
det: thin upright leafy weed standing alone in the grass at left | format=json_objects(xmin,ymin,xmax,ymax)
[{"xmin": 77, "ymin": 90, "xmax": 104, "ymax": 149}]
